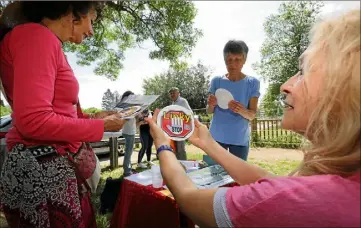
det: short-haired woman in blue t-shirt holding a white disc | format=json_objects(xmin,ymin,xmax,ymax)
[{"xmin": 207, "ymin": 40, "xmax": 260, "ymax": 161}]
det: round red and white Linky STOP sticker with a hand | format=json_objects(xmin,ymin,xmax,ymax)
[{"xmin": 157, "ymin": 105, "xmax": 194, "ymax": 141}]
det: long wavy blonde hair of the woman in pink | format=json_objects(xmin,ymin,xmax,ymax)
[{"xmin": 291, "ymin": 10, "xmax": 360, "ymax": 177}]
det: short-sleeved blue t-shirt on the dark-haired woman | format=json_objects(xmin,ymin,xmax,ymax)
[{"xmin": 209, "ymin": 76, "xmax": 260, "ymax": 146}]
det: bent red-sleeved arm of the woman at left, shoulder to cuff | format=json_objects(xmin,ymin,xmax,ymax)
[{"xmin": 10, "ymin": 27, "xmax": 104, "ymax": 142}]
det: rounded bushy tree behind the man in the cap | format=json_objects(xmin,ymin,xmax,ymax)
[{"xmin": 143, "ymin": 62, "xmax": 212, "ymax": 109}]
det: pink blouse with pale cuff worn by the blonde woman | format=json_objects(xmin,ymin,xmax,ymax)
[{"xmin": 214, "ymin": 172, "xmax": 360, "ymax": 227}]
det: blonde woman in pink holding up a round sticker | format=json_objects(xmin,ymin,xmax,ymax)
[{"xmin": 147, "ymin": 10, "xmax": 360, "ymax": 227}]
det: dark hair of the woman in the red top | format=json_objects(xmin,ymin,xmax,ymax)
[{"xmin": 21, "ymin": 1, "xmax": 101, "ymax": 23}]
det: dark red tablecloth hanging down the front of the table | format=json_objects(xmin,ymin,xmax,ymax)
[{"xmin": 110, "ymin": 179, "xmax": 236, "ymax": 228}]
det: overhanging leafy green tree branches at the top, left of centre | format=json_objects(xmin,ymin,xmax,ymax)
[{"xmin": 0, "ymin": 0, "xmax": 202, "ymax": 80}]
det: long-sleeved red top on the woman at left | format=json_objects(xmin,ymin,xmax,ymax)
[{"xmin": 0, "ymin": 23, "xmax": 104, "ymax": 152}]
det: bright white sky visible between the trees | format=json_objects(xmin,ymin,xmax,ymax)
[{"xmin": 3, "ymin": 1, "xmax": 360, "ymax": 108}]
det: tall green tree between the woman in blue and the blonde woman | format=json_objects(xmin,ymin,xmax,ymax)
[{"xmin": 253, "ymin": 1, "xmax": 323, "ymax": 116}]
